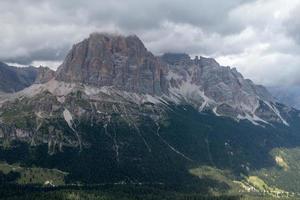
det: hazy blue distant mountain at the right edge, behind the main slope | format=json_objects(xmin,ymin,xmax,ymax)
[{"xmin": 268, "ymin": 86, "xmax": 300, "ymax": 109}]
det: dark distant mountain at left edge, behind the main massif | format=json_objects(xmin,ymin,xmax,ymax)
[{"xmin": 0, "ymin": 62, "xmax": 54, "ymax": 93}]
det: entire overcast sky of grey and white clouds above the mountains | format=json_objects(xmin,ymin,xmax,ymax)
[{"xmin": 0, "ymin": 0, "xmax": 300, "ymax": 86}]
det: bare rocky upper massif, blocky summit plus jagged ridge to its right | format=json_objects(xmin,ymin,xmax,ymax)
[{"xmin": 56, "ymin": 33, "xmax": 287, "ymax": 124}]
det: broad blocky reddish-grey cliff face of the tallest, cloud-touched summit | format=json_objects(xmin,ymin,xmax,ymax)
[{"xmin": 56, "ymin": 33, "xmax": 166, "ymax": 94}]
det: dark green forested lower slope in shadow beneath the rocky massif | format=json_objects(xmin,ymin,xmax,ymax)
[{"xmin": 0, "ymin": 98, "xmax": 300, "ymax": 195}]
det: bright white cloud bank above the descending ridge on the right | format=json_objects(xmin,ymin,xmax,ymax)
[{"xmin": 214, "ymin": 0, "xmax": 300, "ymax": 86}]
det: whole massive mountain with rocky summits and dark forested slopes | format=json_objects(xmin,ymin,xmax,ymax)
[{"xmin": 0, "ymin": 33, "xmax": 300, "ymax": 196}]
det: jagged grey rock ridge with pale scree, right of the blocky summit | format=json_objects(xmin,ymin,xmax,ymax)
[{"xmin": 162, "ymin": 54, "xmax": 288, "ymax": 124}]
